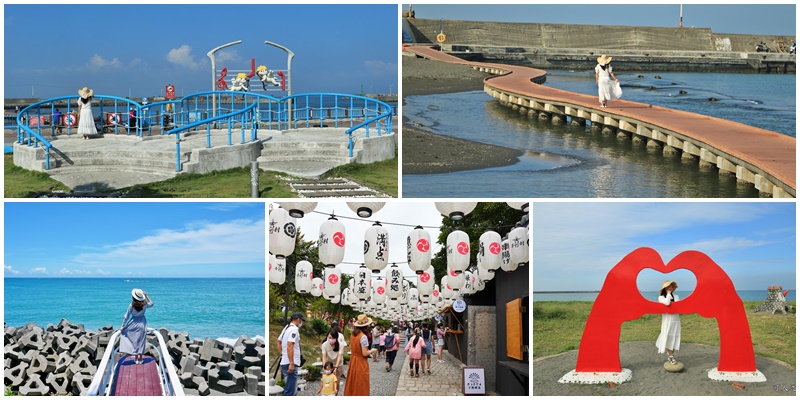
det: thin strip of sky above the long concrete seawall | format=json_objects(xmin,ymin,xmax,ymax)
[{"xmin": 403, "ymin": 3, "xmax": 797, "ymax": 36}]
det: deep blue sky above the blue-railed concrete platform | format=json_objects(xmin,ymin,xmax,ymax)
[{"xmin": 4, "ymin": 4, "xmax": 399, "ymax": 98}]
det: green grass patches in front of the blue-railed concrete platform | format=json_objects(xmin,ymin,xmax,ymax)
[{"xmin": 4, "ymin": 155, "xmax": 398, "ymax": 198}]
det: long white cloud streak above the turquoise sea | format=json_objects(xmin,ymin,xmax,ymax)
[{"xmin": 72, "ymin": 219, "xmax": 266, "ymax": 272}]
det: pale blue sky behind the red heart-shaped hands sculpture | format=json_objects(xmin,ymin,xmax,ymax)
[{"xmin": 532, "ymin": 201, "xmax": 797, "ymax": 291}]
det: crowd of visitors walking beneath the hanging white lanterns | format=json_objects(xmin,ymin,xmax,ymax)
[{"xmin": 277, "ymin": 313, "xmax": 447, "ymax": 396}]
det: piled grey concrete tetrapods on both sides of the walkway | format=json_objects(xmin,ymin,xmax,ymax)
[{"xmin": 3, "ymin": 319, "xmax": 266, "ymax": 396}]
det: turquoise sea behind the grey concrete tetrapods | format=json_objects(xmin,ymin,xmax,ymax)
[{"xmin": 3, "ymin": 278, "xmax": 265, "ymax": 339}]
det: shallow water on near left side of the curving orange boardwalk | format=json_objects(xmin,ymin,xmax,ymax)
[{"xmin": 403, "ymin": 91, "xmax": 758, "ymax": 198}]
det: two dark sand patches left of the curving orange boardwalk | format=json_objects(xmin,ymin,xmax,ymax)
[{"xmin": 402, "ymin": 57, "xmax": 523, "ymax": 174}]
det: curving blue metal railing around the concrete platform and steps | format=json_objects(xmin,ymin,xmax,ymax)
[{"xmin": 16, "ymin": 91, "xmax": 394, "ymax": 171}]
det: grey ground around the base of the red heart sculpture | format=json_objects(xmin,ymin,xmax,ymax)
[{"xmin": 533, "ymin": 342, "xmax": 796, "ymax": 396}]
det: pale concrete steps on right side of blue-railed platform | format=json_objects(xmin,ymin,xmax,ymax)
[{"xmin": 258, "ymin": 128, "xmax": 362, "ymax": 178}]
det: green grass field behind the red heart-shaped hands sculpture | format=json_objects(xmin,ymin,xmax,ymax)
[{"xmin": 533, "ymin": 301, "xmax": 797, "ymax": 367}]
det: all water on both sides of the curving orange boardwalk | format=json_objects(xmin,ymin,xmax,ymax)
[{"xmin": 403, "ymin": 71, "xmax": 796, "ymax": 198}]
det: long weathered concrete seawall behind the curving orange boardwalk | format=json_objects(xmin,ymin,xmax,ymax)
[{"xmin": 407, "ymin": 19, "xmax": 796, "ymax": 73}]
